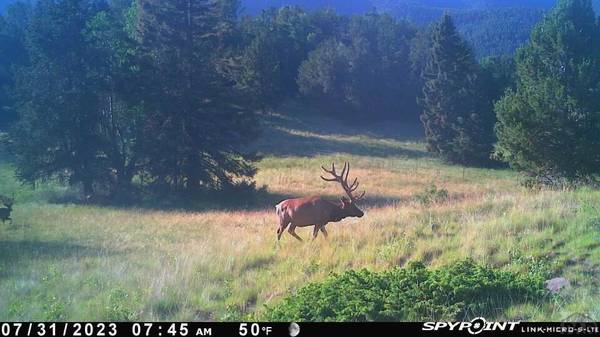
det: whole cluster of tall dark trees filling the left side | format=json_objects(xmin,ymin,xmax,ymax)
[{"xmin": 3, "ymin": 0, "xmax": 257, "ymax": 196}]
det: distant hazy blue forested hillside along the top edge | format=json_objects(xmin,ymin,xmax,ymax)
[{"xmin": 242, "ymin": 0, "xmax": 600, "ymax": 58}]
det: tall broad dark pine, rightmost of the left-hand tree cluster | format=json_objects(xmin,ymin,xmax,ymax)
[{"xmin": 138, "ymin": 0, "xmax": 257, "ymax": 191}]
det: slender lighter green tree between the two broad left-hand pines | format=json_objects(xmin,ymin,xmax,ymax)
[{"xmin": 84, "ymin": 1, "xmax": 146, "ymax": 194}]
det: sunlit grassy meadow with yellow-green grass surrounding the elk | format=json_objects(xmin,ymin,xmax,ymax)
[{"xmin": 0, "ymin": 111, "xmax": 600, "ymax": 320}]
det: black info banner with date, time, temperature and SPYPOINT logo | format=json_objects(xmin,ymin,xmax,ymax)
[{"xmin": 0, "ymin": 318, "xmax": 600, "ymax": 337}]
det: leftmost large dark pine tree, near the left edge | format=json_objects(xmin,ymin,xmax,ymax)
[{"xmin": 11, "ymin": 0, "xmax": 110, "ymax": 195}]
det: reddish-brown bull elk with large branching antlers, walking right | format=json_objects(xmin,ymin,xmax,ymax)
[{"xmin": 275, "ymin": 163, "xmax": 365, "ymax": 241}]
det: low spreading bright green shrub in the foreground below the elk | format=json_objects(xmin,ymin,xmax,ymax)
[{"xmin": 264, "ymin": 260, "xmax": 544, "ymax": 321}]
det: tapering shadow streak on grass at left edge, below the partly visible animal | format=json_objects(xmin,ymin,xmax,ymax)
[{"xmin": 0, "ymin": 240, "xmax": 119, "ymax": 277}]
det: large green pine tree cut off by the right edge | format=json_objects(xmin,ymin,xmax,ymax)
[{"xmin": 496, "ymin": 0, "xmax": 600, "ymax": 183}]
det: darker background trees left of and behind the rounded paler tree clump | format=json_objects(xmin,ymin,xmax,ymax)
[{"xmin": 239, "ymin": 7, "xmax": 345, "ymax": 109}]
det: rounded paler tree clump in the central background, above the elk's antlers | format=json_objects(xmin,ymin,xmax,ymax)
[{"xmin": 298, "ymin": 13, "xmax": 418, "ymax": 120}]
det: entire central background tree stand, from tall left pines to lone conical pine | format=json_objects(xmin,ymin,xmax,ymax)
[{"xmin": 234, "ymin": 7, "xmax": 418, "ymax": 120}]
